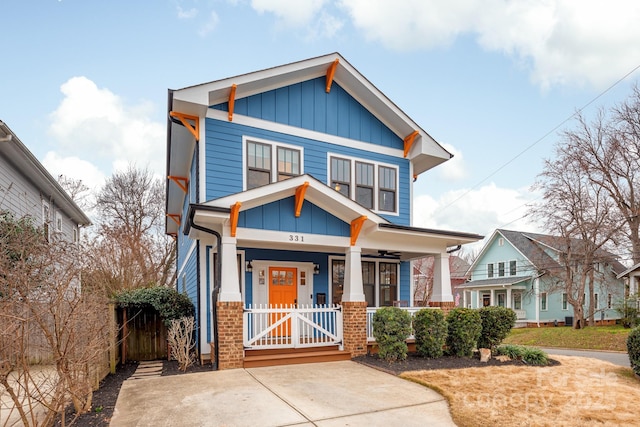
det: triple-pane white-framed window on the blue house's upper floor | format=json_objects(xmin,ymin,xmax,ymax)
[{"xmin": 329, "ymin": 156, "xmax": 398, "ymax": 213}]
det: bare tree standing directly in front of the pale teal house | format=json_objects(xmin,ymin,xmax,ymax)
[{"xmin": 531, "ymin": 114, "xmax": 624, "ymax": 328}]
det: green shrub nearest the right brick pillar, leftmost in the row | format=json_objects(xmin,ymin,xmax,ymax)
[{"xmin": 373, "ymin": 307, "xmax": 411, "ymax": 362}]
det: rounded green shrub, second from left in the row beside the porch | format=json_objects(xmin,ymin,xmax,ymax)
[{"xmin": 413, "ymin": 308, "xmax": 447, "ymax": 359}]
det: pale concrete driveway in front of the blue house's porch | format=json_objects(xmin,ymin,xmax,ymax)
[{"xmin": 110, "ymin": 361, "xmax": 455, "ymax": 427}]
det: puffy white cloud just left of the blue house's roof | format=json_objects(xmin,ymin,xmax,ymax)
[{"xmin": 49, "ymin": 77, "xmax": 166, "ymax": 178}]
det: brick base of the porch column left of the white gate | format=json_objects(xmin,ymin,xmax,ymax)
[{"xmin": 217, "ymin": 301, "xmax": 244, "ymax": 370}]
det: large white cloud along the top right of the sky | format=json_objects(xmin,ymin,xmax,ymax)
[{"xmin": 337, "ymin": 0, "xmax": 640, "ymax": 88}]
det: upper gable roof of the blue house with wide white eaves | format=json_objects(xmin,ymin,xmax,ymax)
[{"xmin": 167, "ymin": 53, "xmax": 453, "ymax": 236}]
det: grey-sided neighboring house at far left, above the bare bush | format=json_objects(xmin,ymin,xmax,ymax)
[{"xmin": 0, "ymin": 121, "xmax": 91, "ymax": 242}]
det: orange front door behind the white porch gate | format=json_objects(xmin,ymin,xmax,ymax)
[{"xmin": 269, "ymin": 267, "xmax": 298, "ymax": 337}]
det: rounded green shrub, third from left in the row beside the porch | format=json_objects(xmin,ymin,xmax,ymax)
[{"xmin": 446, "ymin": 308, "xmax": 482, "ymax": 356}]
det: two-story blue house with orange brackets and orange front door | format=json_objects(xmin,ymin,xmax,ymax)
[{"xmin": 166, "ymin": 53, "xmax": 482, "ymax": 369}]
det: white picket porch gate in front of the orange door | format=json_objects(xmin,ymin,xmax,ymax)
[{"xmin": 243, "ymin": 305, "xmax": 343, "ymax": 350}]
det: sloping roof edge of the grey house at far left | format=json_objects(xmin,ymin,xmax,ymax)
[{"xmin": 0, "ymin": 120, "xmax": 91, "ymax": 226}]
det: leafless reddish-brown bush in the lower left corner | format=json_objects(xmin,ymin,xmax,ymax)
[{"xmin": 0, "ymin": 213, "xmax": 108, "ymax": 426}]
